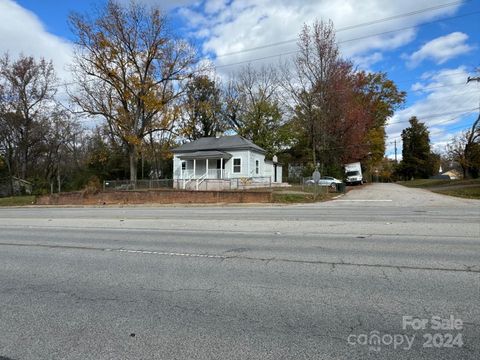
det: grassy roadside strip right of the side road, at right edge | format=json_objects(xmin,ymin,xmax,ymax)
[{"xmin": 398, "ymin": 179, "xmax": 480, "ymax": 199}]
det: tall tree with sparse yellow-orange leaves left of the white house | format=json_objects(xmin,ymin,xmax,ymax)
[{"xmin": 70, "ymin": 0, "xmax": 195, "ymax": 180}]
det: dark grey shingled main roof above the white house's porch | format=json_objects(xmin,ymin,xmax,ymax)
[{"xmin": 172, "ymin": 135, "xmax": 265, "ymax": 153}]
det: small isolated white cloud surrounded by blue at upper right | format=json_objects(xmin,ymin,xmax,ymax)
[{"xmin": 407, "ymin": 32, "xmax": 473, "ymax": 67}]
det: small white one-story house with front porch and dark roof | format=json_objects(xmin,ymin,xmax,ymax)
[{"xmin": 172, "ymin": 135, "xmax": 282, "ymax": 190}]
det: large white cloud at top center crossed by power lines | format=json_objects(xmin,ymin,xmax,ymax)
[{"xmin": 179, "ymin": 0, "xmax": 461, "ymax": 73}]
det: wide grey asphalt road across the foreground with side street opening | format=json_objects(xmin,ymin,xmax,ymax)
[{"xmin": 0, "ymin": 184, "xmax": 480, "ymax": 360}]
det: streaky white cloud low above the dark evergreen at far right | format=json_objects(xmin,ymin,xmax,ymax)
[{"xmin": 387, "ymin": 66, "xmax": 479, "ymax": 154}]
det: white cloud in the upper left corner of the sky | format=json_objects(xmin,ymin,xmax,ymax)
[{"xmin": 0, "ymin": 0, "xmax": 72, "ymax": 80}]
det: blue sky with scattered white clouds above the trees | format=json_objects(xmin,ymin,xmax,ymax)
[{"xmin": 0, "ymin": 0, "xmax": 480, "ymax": 157}]
